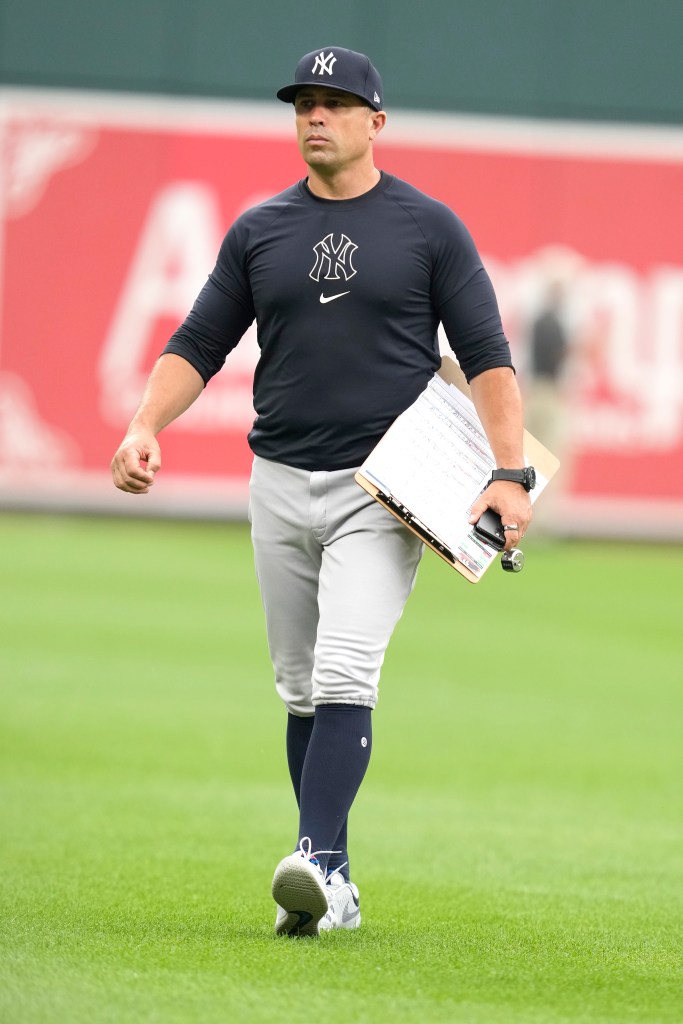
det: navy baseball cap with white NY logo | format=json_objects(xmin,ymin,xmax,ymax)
[{"xmin": 278, "ymin": 46, "xmax": 382, "ymax": 111}]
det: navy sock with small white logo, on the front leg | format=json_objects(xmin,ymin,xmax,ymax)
[{"xmin": 295, "ymin": 705, "xmax": 373, "ymax": 877}]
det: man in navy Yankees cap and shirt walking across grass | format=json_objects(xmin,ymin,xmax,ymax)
[{"xmin": 113, "ymin": 46, "xmax": 530, "ymax": 935}]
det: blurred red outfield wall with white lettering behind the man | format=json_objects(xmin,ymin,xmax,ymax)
[{"xmin": 0, "ymin": 89, "xmax": 683, "ymax": 537}]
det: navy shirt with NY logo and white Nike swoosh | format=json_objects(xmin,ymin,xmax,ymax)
[{"xmin": 164, "ymin": 174, "xmax": 512, "ymax": 470}]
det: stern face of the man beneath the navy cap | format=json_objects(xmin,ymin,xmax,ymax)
[{"xmin": 294, "ymin": 85, "xmax": 383, "ymax": 170}]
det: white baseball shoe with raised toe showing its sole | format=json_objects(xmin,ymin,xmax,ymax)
[{"xmin": 271, "ymin": 837, "xmax": 329, "ymax": 935}]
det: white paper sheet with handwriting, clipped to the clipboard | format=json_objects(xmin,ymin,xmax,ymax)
[{"xmin": 358, "ymin": 375, "xmax": 548, "ymax": 580}]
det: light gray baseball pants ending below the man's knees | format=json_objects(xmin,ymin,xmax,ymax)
[{"xmin": 249, "ymin": 456, "xmax": 422, "ymax": 717}]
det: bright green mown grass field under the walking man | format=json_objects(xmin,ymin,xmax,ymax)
[{"xmin": 0, "ymin": 515, "xmax": 683, "ymax": 1024}]
